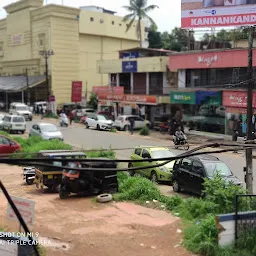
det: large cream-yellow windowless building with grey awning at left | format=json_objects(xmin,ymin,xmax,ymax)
[{"xmin": 0, "ymin": 0, "xmax": 144, "ymax": 106}]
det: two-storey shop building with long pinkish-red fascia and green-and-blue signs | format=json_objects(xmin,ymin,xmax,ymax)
[{"xmin": 169, "ymin": 48, "xmax": 256, "ymax": 135}]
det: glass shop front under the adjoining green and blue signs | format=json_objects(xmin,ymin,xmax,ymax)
[{"xmin": 171, "ymin": 91, "xmax": 225, "ymax": 133}]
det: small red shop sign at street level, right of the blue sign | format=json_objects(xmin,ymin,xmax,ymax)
[{"xmin": 222, "ymin": 91, "xmax": 256, "ymax": 108}]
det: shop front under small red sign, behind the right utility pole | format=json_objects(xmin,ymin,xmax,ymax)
[{"xmin": 223, "ymin": 90, "xmax": 256, "ymax": 136}]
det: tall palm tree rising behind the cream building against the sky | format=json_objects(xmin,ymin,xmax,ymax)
[{"xmin": 123, "ymin": 0, "xmax": 159, "ymax": 47}]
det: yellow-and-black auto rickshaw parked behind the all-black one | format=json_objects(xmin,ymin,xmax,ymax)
[{"xmin": 35, "ymin": 150, "xmax": 86, "ymax": 192}]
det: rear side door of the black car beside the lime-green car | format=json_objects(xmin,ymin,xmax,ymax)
[{"xmin": 178, "ymin": 158, "xmax": 192, "ymax": 191}]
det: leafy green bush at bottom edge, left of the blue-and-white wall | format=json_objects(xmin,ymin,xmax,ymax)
[{"xmin": 184, "ymin": 215, "xmax": 218, "ymax": 256}]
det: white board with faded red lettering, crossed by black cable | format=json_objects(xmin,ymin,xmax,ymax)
[{"xmin": 7, "ymin": 196, "xmax": 35, "ymax": 224}]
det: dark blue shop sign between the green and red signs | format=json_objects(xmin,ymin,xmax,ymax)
[{"xmin": 196, "ymin": 91, "xmax": 222, "ymax": 106}]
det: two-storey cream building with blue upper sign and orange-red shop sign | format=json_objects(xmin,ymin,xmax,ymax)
[{"xmin": 98, "ymin": 48, "xmax": 178, "ymax": 122}]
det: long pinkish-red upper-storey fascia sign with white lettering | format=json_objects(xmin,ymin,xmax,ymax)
[{"xmin": 169, "ymin": 49, "xmax": 256, "ymax": 70}]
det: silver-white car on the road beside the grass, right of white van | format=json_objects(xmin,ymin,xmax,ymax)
[{"xmin": 29, "ymin": 123, "xmax": 64, "ymax": 140}]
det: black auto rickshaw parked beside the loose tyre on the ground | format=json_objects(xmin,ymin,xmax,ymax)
[{"xmin": 59, "ymin": 158, "xmax": 118, "ymax": 199}]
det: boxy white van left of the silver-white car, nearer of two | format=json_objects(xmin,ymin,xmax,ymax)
[{"xmin": 3, "ymin": 115, "xmax": 26, "ymax": 134}]
